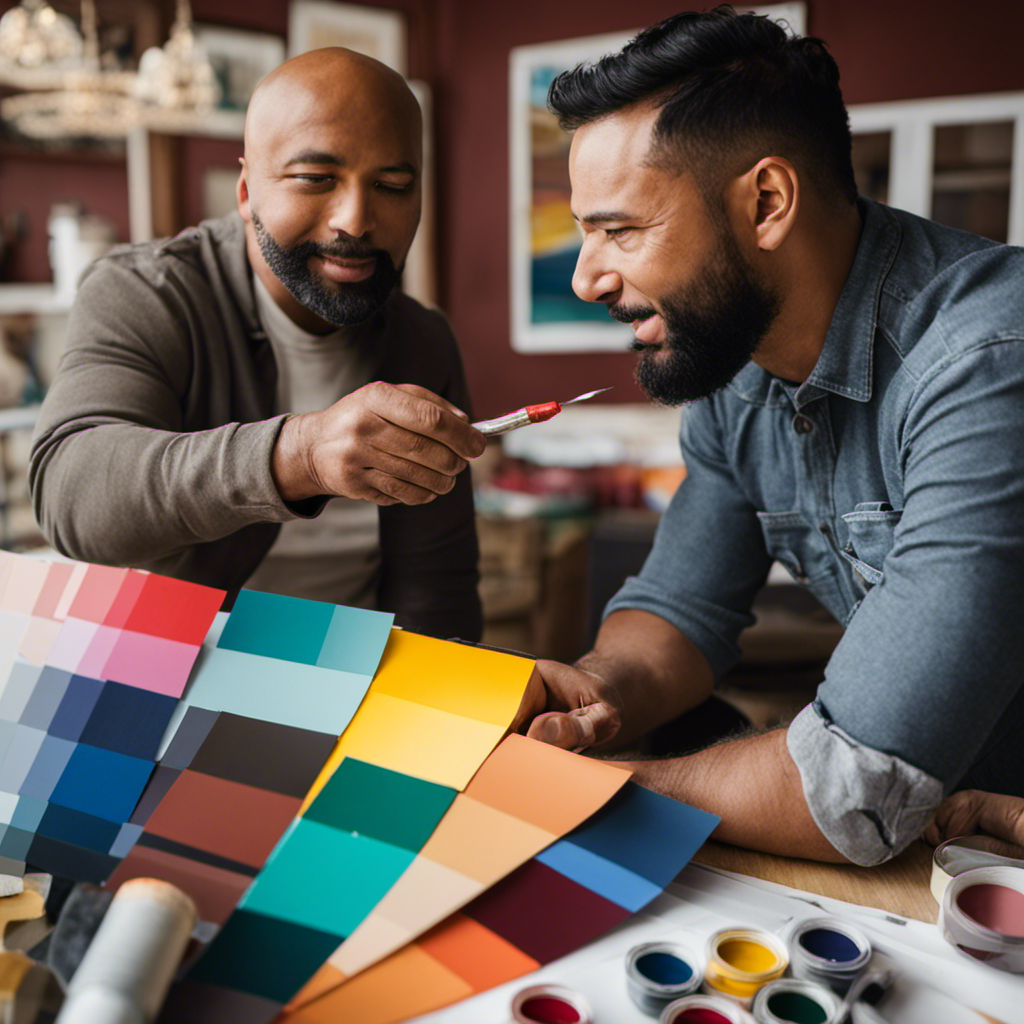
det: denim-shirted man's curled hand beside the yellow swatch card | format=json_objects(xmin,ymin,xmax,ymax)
[{"xmin": 526, "ymin": 662, "xmax": 622, "ymax": 751}]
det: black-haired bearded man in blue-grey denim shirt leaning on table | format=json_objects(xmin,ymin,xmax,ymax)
[{"xmin": 528, "ymin": 8, "xmax": 1024, "ymax": 864}]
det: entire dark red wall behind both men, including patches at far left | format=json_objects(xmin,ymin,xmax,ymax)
[{"xmin": 0, "ymin": 0, "xmax": 1024, "ymax": 415}]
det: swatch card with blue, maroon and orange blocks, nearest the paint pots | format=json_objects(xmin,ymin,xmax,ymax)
[{"xmin": 280, "ymin": 782, "xmax": 719, "ymax": 1024}]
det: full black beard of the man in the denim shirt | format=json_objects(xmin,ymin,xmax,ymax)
[{"xmin": 609, "ymin": 224, "xmax": 779, "ymax": 406}]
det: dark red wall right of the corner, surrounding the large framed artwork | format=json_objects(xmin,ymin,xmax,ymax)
[{"xmin": 437, "ymin": 0, "xmax": 1024, "ymax": 416}]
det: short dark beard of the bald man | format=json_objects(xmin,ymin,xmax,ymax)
[{"xmin": 252, "ymin": 212, "xmax": 401, "ymax": 327}]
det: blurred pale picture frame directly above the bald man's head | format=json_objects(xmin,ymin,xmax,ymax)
[{"xmin": 288, "ymin": 0, "xmax": 408, "ymax": 75}]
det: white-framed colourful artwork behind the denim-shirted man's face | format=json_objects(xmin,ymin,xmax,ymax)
[{"xmin": 509, "ymin": 3, "xmax": 807, "ymax": 352}]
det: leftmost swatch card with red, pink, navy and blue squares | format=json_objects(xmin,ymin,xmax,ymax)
[{"xmin": 0, "ymin": 553, "xmax": 224, "ymax": 882}]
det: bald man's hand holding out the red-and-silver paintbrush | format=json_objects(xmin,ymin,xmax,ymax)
[{"xmin": 271, "ymin": 381, "xmax": 486, "ymax": 505}]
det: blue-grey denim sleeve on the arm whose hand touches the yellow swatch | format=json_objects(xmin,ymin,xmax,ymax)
[{"xmin": 605, "ymin": 400, "xmax": 771, "ymax": 678}]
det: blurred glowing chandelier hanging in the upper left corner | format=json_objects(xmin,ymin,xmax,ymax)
[{"xmin": 0, "ymin": 0, "xmax": 219, "ymax": 139}]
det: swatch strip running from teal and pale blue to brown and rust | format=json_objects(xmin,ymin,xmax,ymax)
[{"xmin": 103, "ymin": 590, "xmax": 394, "ymax": 925}]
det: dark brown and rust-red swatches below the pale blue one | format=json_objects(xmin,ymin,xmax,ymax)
[{"xmin": 108, "ymin": 708, "xmax": 336, "ymax": 925}]
